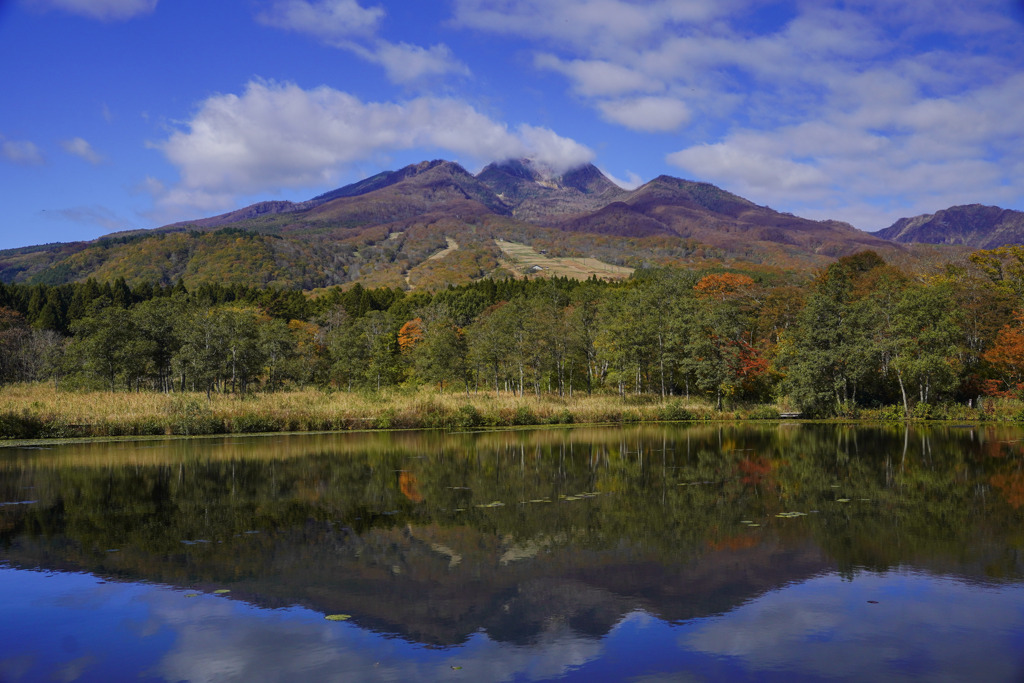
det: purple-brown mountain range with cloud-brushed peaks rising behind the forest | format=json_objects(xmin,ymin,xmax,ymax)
[{"xmin": 0, "ymin": 160, "xmax": 1024, "ymax": 289}]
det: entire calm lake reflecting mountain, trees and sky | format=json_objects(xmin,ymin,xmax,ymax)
[{"xmin": 0, "ymin": 423, "xmax": 1024, "ymax": 682}]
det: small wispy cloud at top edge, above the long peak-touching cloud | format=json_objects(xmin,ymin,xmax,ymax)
[{"xmin": 256, "ymin": 0, "xmax": 469, "ymax": 84}]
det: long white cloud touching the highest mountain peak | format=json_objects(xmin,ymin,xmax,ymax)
[{"xmin": 155, "ymin": 81, "xmax": 594, "ymax": 216}]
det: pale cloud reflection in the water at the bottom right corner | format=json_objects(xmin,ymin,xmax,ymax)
[{"xmin": 680, "ymin": 573, "xmax": 1024, "ymax": 681}]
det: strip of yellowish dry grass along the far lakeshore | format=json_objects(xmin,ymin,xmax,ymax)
[{"xmin": 0, "ymin": 384, "xmax": 1024, "ymax": 439}]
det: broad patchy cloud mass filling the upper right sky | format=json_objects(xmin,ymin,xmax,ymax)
[{"xmin": 455, "ymin": 0, "xmax": 1024, "ymax": 229}]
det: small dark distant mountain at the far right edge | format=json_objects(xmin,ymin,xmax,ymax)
[{"xmin": 874, "ymin": 204, "xmax": 1024, "ymax": 249}]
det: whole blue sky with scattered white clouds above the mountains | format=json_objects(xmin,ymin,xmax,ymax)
[{"xmin": 0, "ymin": 0, "xmax": 1024, "ymax": 249}]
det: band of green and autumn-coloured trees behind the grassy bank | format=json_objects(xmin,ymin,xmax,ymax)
[{"xmin": 6, "ymin": 248, "xmax": 1024, "ymax": 415}]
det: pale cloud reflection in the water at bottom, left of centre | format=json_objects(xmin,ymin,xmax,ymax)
[{"xmin": 146, "ymin": 592, "xmax": 602, "ymax": 682}]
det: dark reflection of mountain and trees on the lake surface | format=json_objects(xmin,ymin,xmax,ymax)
[{"xmin": 0, "ymin": 426, "xmax": 1024, "ymax": 645}]
